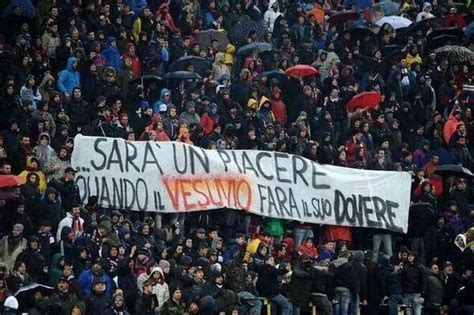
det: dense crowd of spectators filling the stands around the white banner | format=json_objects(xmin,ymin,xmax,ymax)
[{"xmin": 0, "ymin": 0, "xmax": 474, "ymax": 315}]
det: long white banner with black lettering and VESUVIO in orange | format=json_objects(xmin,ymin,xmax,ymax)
[{"xmin": 72, "ymin": 135, "xmax": 411, "ymax": 232}]
